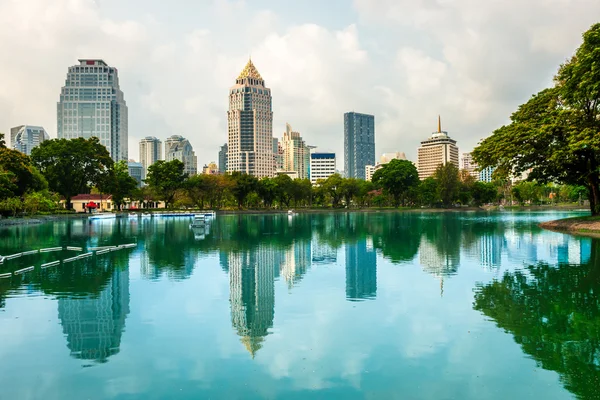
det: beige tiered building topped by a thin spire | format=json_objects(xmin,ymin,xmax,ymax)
[{"xmin": 417, "ymin": 117, "xmax": 459, "ymax": 180}]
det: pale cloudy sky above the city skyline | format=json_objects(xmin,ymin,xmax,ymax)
[{"xmin": 0, "ymin": 0, "xmax": 600, "ymax": 169}]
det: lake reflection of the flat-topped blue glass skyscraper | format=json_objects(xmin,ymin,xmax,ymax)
[{"xmin": 345, "ymin": 237, "xmax": 377, "ymax": 301}]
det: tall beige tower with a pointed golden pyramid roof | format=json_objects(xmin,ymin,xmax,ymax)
[{"xmin": 227, "ymin": 60, "xmax": 275, "ymax": 178}]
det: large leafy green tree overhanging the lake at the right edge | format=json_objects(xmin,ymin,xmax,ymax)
[{"xmin": 473, "ymin": 24, "xmax": 600, "ymax": 215}]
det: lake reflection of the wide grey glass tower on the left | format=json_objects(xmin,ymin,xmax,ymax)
[{"xmin": 58, "ymin": 268, "xmax": 129, "ymax": 362}]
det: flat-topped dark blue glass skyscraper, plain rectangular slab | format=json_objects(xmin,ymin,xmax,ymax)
[{"xmin": 344, "ymin": 112, "xmax": 375, "ymax": 179}]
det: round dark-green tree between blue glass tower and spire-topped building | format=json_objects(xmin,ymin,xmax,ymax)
[{"xmin": 373, "ymin": 160, "xmax": 419, "ymax": 207}]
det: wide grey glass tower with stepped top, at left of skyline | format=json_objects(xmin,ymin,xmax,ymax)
[{"xmin": 57, "ymin": 59, "xmax": 128, "ymax": 161}]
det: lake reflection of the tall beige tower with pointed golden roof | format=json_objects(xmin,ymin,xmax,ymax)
[{"xmin": 229, "ymin": 246, "xmax": 281, "ymax": 358}]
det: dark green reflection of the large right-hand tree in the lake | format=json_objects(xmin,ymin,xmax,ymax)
[{"xmin": 474, "ymin": 241, "xmax": 600, "ymax": 399}]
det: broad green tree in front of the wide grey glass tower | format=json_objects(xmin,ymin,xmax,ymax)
[{"xmin": 31, "ymin": 137, "xmax": 113, "ymax": 208}]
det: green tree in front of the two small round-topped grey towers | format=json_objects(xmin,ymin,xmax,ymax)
[{"xmin": 144, "ymin": 160, "xmax": 187, "ymax": 208}]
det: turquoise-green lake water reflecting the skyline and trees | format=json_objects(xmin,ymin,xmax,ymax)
[{"xmin": 0, "ymin": 212, "xmax": 600, "ymax": 400}]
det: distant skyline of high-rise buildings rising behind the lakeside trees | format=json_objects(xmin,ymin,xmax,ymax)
[{"xmin": 10, "ymin": 59, "xmax": 493, "ymax": 186}]
